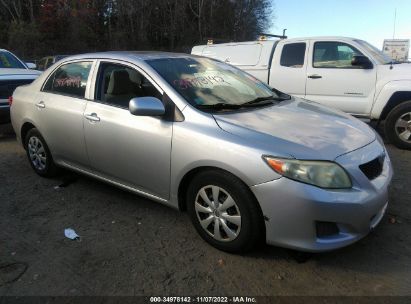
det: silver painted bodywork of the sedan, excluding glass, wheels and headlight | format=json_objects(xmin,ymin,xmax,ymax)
[{"xmin": 11, "ymin": 52, "xmax": 392, "ymax": 251}]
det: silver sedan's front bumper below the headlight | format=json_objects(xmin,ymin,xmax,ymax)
[{"xmin": 251, "ymin": 141, "xmax": 393, "ymax": 252}]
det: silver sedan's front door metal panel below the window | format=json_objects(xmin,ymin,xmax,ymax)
[{"xmin": 84, "ymin": 101, "xmax": 173, "ymax": 199}]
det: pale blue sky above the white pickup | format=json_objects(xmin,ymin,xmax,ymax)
[{"xmin": 271, "ymin": 0, "xmax": 411, "ymax": 49}]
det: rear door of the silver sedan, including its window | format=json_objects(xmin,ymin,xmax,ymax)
[{"xmin": 33, "ymin": 60, "xmax": 94, "ymax": 168}]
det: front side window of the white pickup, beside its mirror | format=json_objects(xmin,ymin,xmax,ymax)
[{"xmin": 313, "ymin": 41, "xmax": 362, "ymax": 69}]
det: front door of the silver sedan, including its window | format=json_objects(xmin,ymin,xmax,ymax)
[{"xmin": 84, "ymin": 61, "xmax": 173, "ymax": 199}]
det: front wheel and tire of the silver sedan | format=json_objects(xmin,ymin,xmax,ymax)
[{"xmin": 187, "ymin": 170, "xmax": 265, "ymax": 252}]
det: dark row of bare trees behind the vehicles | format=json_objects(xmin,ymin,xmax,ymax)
[{"xmin": 0, "ymin": 0, "xmax": 273, "ymax": 59}]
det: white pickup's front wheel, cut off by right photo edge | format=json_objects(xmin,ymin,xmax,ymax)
[{"xmin": 385, "ymin": 101, "xmax": 411, "ymax": 150}]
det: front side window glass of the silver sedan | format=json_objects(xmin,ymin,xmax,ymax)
[{"xmin": 95, "ymin": 62, "xmax": 163, "ymax": 109}]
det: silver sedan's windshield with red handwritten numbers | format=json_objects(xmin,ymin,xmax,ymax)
[{"xmin": 147, "ymin": 57, "xmax": 279, "ymax": 109}]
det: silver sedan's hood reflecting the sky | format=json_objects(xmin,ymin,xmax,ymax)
[{"xmin": 214, "ymin": 98, "xmax": 376, "ymax": 160}]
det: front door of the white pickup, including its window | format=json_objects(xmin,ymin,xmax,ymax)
[{"xmin": 305, "ymin": 41, "xmax": 376, "ymax": 115}]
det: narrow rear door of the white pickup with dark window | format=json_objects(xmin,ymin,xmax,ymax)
[{"xmin": 269, "ymin": 41, "xmax": 307, "ymax": 97}]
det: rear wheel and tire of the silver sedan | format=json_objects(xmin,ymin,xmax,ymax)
[{"xmin": 24, "ymin": 128, "xmax": 58, "ymax": 177}]
